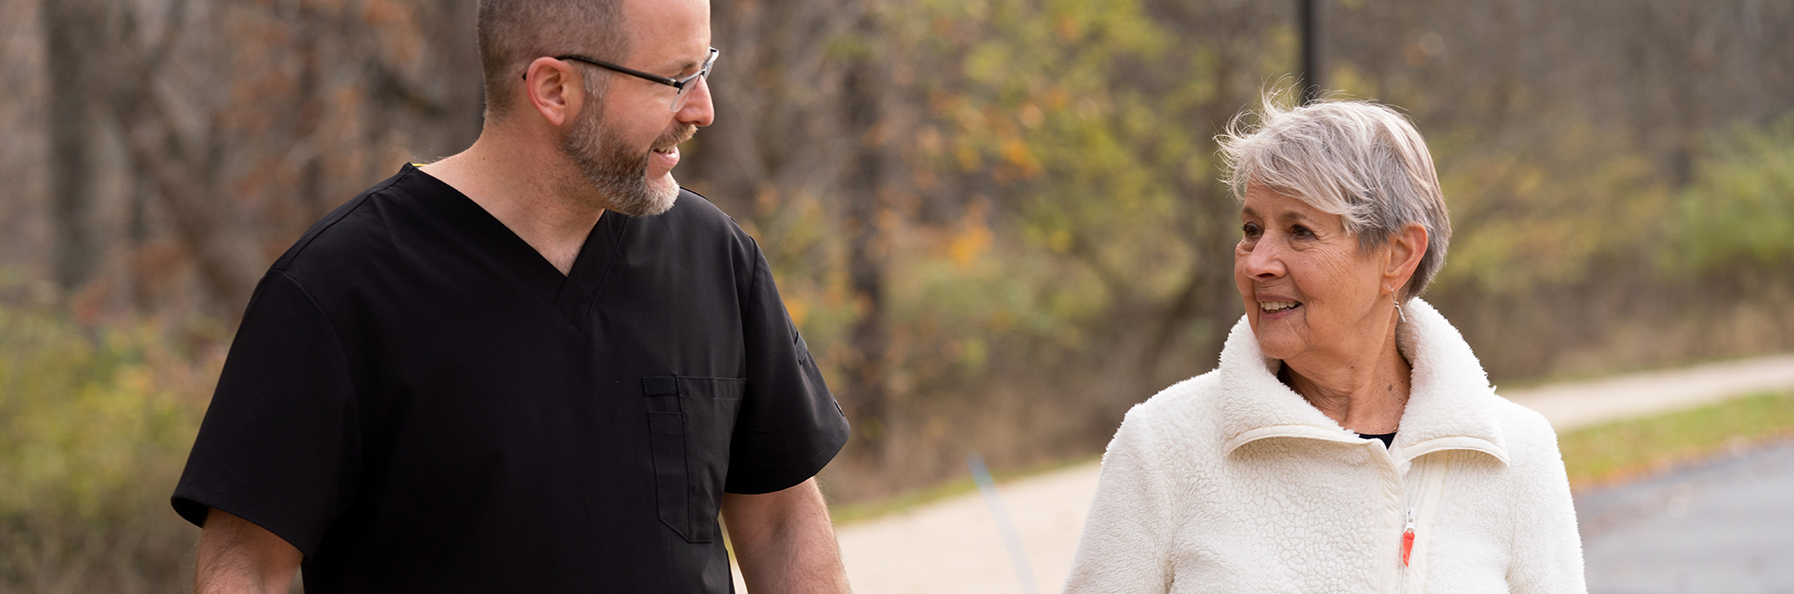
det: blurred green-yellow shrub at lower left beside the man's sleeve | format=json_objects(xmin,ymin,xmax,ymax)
[{"xmin": 0, "ymin": 309, "xmax": 217, "ymax": 592}]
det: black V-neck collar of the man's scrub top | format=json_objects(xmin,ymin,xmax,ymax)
[{"xmin": 402, "ymin": 163, "xmax": 630, "ymax": 330}]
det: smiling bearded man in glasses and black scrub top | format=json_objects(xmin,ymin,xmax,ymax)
[{"xmin": 174, "ymin": 0, "xmax": 847, "ymax": 592}]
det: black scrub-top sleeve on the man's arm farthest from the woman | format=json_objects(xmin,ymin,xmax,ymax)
[{"xmin": 172, "ymin": 271, "xmax": 359, "ymax": 558}]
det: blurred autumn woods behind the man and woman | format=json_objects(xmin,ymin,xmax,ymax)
[{"xmin": 0, "ymin": 0, "xmax": 1794, "ymax": 592}]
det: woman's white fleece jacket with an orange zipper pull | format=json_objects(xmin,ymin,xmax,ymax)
[{"xmin": 1066, "ymin": 300, "xmax": 1588, "ymax": 594}]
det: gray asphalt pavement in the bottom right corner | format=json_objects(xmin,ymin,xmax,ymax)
[{"xmin": 1575, "ymin": 440, "xmax": 1794, "ymax": 594}]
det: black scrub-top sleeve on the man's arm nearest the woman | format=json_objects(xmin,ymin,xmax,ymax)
[{"xmin": 723, "ymin": 248, "xmax": 847, "ymax": 495}]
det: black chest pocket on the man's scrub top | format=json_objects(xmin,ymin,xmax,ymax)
[{"xmin": 642, "ymin": 377, "xmax": 748, "ymax": 542}]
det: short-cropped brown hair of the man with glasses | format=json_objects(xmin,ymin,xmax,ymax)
[{"xmin": 477, "ymin": 0, "xmax": 630, "ymax": 120}]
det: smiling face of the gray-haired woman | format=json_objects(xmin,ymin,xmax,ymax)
[{"xmin": 1234, "ymin": 185, "xmax": 1394, "ymax": 363}]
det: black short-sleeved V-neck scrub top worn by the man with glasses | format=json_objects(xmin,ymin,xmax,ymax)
[{"xmin": 174, "ymin": 165, "xmax": 847, "ymax": 594}]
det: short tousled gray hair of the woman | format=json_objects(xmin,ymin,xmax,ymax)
[{"xmin": 1215, "ymin": 93, "xmax": 1451, "ymax": 300}]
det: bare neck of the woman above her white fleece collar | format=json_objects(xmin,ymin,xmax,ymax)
[{"xmin": 1277, "ymin": 314, "xmax": 1412, "ymax": 434}]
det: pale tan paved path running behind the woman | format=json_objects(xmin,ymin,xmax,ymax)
[{"xmin": 737, "ymin": 354, "xmax": 1794, "ymax": 594}]
